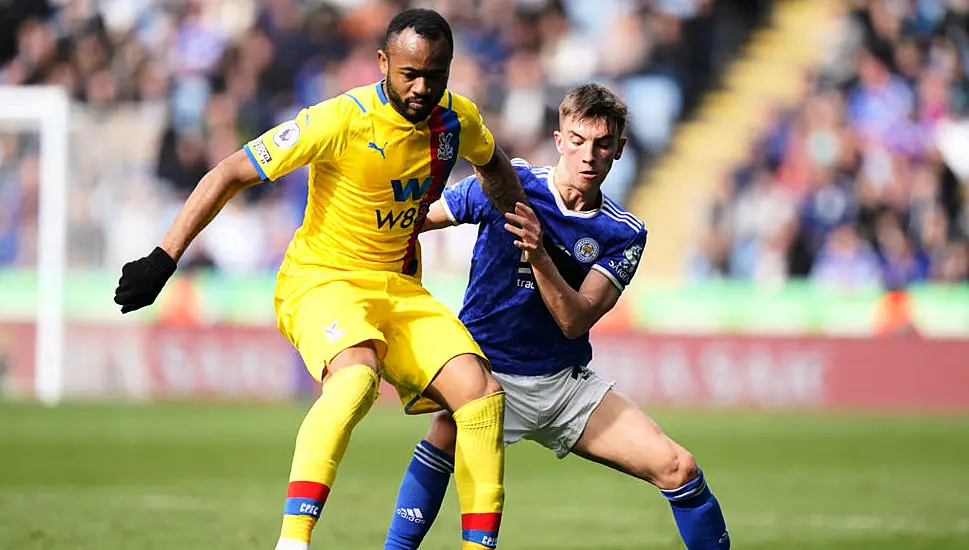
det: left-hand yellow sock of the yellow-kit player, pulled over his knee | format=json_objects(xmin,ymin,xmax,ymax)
[{"xmin": 280, "ymin": 365, "xmax": 380, "ymax": 547}]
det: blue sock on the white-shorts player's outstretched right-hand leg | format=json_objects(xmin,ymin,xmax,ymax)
[{"xmin": 661, "ymin": 470, "xmax": 730, "ymax": 550}]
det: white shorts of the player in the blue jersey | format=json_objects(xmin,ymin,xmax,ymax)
[{"xmin": 494, "ymin": 366, "xmax": 615, "ymax": 458}]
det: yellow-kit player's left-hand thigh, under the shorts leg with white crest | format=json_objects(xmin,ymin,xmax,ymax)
[{"xmin": 276, "ymin": 274, "xmax": 389, "ymax": 380}]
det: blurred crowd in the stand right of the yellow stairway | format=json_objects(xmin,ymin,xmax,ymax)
[{"xmin": 689, "ymin": 0, "xmax": 969, "ymax": 290}]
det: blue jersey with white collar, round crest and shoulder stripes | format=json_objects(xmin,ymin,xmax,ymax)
[{"xmin": 442, "ymin": 159, "xmax": 646, "ymax": 376}]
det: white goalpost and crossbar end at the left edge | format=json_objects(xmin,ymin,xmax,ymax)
[{"xmin": 0, "ymin": 86, "xmax": 71, "ymax": 406}]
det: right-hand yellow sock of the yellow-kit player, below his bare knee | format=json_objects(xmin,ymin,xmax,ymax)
[{"xmin": 453, "ymin": 392, "xmax": 505, "ymax": 550}]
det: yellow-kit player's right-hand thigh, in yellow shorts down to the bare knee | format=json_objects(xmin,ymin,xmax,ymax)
[{"xmin": 384, "ymin": 281, "xmax": 500, "ymax": 414}]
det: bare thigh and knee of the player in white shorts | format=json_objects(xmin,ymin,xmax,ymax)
[{"xmin": 572, "ymin": 390, "xmax": 696, "ymax": 489}]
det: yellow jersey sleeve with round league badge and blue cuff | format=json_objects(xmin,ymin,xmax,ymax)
[{"xmin": 243, "ymin": 96, "xmax": 352, "ymax": 181}]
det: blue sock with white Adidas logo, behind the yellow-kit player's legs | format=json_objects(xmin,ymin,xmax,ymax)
[{"xmin": 384, "ymin": 441, "xmax": 454, "ymax": 550}]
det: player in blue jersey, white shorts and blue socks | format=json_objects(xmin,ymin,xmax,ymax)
[{"xmin": 384, "ymin": 84, "xmax": 730, "ymax": 550}]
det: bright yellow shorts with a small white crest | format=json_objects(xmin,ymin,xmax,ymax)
[{"xmin": 275, "ymin": 268, "xmax": 484, "ymax": 414}]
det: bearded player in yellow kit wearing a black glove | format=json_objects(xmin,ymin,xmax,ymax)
[{"xmin": 115, "ymin": 10, "xmax": 525, "ymax": 550}]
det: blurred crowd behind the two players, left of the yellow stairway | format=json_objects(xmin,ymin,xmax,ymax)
[{"xmin": 0, "ymin": 0, "xmax": 762, "ymax": 273}]
